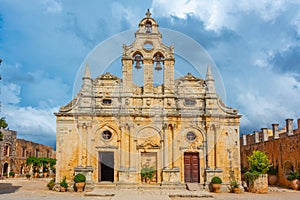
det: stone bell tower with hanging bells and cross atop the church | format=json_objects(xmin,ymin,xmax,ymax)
[{"xmin": 122, "ymin": 9, "xmax": 175, "ymax": 95}]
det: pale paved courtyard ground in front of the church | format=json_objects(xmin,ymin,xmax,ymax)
[{"xmin": 0, "ymin": 178, "xmax": 300, "ymax": 200}]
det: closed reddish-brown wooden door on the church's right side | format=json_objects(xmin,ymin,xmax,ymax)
[{"xmin": 184, "ymin": 153, "xmax": 199, "ymax": 183}]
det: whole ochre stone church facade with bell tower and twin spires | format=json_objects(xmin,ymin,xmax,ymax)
[{"xmin": 55, "ymin": 11, "xmax": 241, "ymax": 187}]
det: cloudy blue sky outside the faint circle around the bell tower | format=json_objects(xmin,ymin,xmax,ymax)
[{"xmin": 0, "ymin": 0, "xmax": 300, "ymax": 146}]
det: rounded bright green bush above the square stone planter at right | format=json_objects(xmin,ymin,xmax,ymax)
[{"xmin": 248, "ymin": 150, "xmax": 272, "ymax": 174}]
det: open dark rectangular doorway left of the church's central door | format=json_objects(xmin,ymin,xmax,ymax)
[{"xmin": 98, "ymin": 152, "xmax": 114, "ymax": 182}]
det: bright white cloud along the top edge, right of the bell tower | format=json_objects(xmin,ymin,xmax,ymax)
[{"xmin": 152, "ymin": 0, "xmax": 286, "ymax": 31}]
